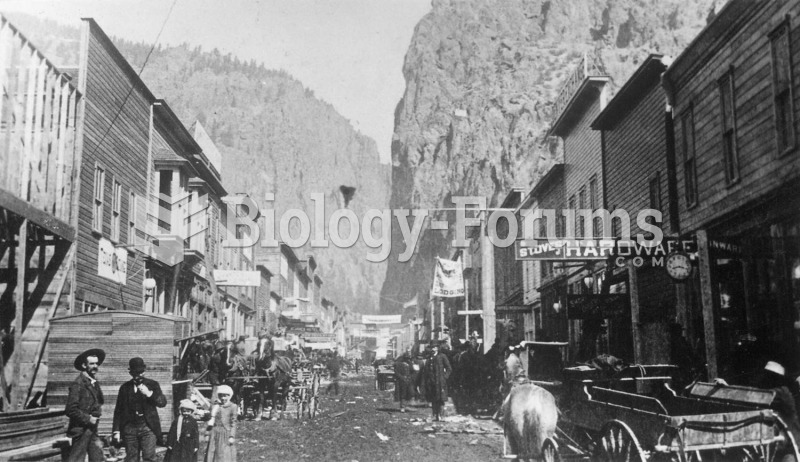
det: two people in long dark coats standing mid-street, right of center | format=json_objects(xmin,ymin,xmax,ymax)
[{"xmin": 394, "ymin": 340, "xmax": 453, "ymax": 421}]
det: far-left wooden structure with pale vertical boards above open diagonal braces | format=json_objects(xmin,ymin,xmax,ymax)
[{"xmin": 0, "ymin": 16, "xmax": 84, "ymax": 411}]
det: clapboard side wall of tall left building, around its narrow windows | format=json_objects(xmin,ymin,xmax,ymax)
[{"xmin": 75, "ymin": 21, "xmax": 150, "ymax": 310}]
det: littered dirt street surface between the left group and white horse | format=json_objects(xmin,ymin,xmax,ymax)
[{"xmin": 209, "ymin": 375, "xmax": 503, "ymax": 462}]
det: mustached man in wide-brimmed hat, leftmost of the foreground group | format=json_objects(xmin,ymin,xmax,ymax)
[{"xmin": 62, "ymin": 348, "xmax": 106, "ymax": 462}]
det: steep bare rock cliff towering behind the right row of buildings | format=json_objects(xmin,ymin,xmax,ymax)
[{"xmin": 381, "ymin": 0, "xmax": 724, "ymax": 312}]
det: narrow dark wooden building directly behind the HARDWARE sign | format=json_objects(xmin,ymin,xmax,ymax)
[{"xmin": 592, "ymin": 55, "xmax": 686, "ymax": 364}]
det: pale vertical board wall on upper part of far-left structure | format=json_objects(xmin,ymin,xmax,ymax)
[{"xmin": 0, "ymin": 16, "xmax": 80, "ymax": 223}]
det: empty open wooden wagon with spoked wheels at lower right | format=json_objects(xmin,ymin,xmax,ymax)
[{"xmin": 506, "ymin": 346, "xmax": 800, "ymax": 462}]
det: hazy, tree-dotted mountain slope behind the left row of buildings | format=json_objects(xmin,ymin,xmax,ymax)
[{"xmin": 4, "ymin": 14, "xmax": 390, "ymax": 313}]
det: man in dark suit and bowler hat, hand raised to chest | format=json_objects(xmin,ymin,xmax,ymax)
[{"xmin": 113, "ymin": 358, "xmax": 167, "ymax": 462}]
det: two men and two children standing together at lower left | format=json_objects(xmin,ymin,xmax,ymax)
[{"xmin": 63, "ymin": 348, "xmax": 238, "ymax": 462}]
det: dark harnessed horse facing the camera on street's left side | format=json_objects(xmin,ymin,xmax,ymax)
[{"xmin": 253, "ymin": 337, "xmax": 292, "ymax": 420}]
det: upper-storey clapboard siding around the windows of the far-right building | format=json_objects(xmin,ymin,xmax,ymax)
[{"xmin": 672, "ymin": 0, "xmax": 800, "ymax": 232}]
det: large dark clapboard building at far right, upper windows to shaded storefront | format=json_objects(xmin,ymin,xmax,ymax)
[{"xmin": 664, "ymin": 0, "xmax": 800, "ymax": 382}]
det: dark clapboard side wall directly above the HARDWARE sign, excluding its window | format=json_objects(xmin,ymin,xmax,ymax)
[{"xmin": 604, "ymin": 82, "xmax": 670, "ymax": 238}]
